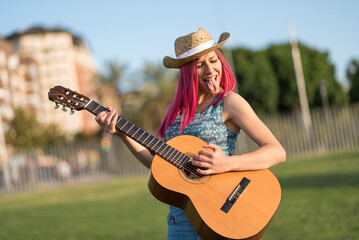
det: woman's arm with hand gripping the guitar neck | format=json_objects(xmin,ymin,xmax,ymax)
[{"xmin": 95, "ymin": 107, "xmax": 163, "ymax": 168}]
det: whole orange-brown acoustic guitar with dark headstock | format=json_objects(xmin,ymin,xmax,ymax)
[{"xmin": 48, "ymin": 86, "xmax": 281, "ymax": 240}]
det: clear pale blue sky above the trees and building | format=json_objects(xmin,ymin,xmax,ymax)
[{"xmin": 0, "ymin": 0, "xmax": 359, "ymax": 85}]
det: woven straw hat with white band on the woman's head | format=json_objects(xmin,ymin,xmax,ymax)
[{"xmin": 163, "ymin": 28, "xmax": 230, "ymax": 68}]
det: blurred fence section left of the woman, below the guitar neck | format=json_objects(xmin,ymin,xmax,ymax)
[{"xmin": 0, "ymin": 134, "xmax": 148, "ymax": 194}]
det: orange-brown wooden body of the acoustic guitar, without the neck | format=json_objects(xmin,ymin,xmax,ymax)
[{"xmin": 148, "ymin": 135, "xmax": 281, "ymax": 240}]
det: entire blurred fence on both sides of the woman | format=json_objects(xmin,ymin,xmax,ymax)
[{"xmin": 0, "ymin": 105, "xmax": 359, "ymax": 194}]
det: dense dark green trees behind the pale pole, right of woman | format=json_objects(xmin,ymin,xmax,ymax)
[{"xmin": 232, "ymin": 43, "xmax": 348, "ymax": 113}]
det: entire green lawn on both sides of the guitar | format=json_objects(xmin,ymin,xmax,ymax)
[{"xmin": 0, "ymin": 151, "xmax": 359, "ymax": 240}]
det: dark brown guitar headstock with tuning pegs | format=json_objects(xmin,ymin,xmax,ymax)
[{"xmin": 48, "ymin": 86, "xmax": 90, "ymax": 114}]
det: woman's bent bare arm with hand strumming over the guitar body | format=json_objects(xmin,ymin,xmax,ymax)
[{"xmin": 193, "ymin": 93, "xmax": 286, "ymax": 174}]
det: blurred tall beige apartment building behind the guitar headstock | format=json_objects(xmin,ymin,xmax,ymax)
[{"xmin": 5, "ymin": 27, "xmax": 97, "ymax": 134}]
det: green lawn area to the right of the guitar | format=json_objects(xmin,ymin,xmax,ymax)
[{"xmin": 263, "ymin": 151, "xmax": 359, "ymax": 240}]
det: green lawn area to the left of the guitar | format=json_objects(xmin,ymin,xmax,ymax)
[{"xmin": 0, "ymin": 177, "xmax": 167, "ymax": 240}]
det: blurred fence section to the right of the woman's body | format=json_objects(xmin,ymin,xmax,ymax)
[{"xmin": 238, "ymin": 105, "xmax": 359, "ymax": 156}]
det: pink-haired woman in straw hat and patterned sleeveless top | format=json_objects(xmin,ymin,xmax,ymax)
[{"xmin": 96, "ymin": 28, "xmax": 286, "ymax": 239}]
